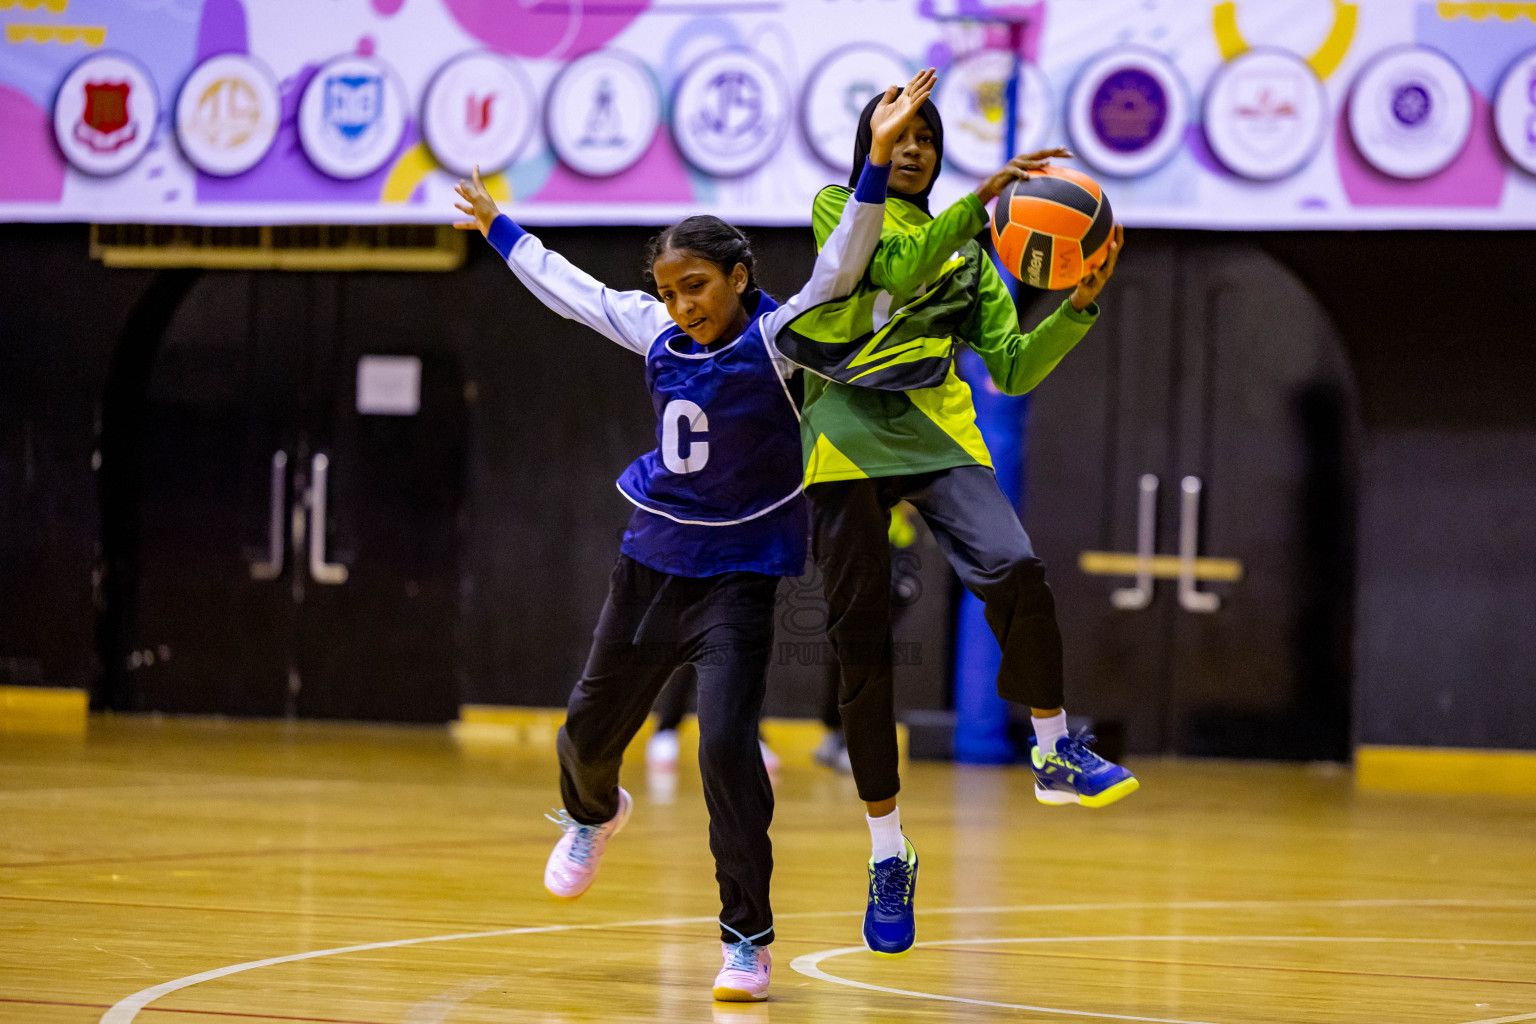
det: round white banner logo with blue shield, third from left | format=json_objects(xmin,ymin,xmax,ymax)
[{"xmin": 298, "ymin": 57, "xmax": 406, "ymax": 178}]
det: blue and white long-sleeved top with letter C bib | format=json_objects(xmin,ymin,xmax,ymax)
[{"xmin": 487, "ymin": 163, "xmax": 889, "ymax": 577}]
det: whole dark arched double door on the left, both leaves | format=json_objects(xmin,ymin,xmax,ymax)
[{"xmin": 111, "ymin": 273, "xmax": 465, "ymax": 722}]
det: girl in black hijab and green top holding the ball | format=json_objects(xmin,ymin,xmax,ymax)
[{"xmin": 779, "ymin": 82, "xmax": 1137, "ymax": 956}]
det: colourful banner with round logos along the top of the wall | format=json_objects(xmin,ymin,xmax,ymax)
[{"xmin": 0, "ymin": 0, "xmax": 1536, "ymax": 229}]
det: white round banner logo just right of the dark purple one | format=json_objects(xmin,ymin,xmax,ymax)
[{"xmin": 1204, "ymin": 49, "xmax": 1329, "ymax": 181}]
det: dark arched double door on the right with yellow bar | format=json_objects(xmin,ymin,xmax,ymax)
[{"xmin": 1026, "ymin": 232, "xmax": 1358, "ymax": 757}]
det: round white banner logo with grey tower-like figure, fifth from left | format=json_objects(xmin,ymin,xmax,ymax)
[{"xmin": 544, "ymin": 49, "xmax": 662, "ymax": 178}]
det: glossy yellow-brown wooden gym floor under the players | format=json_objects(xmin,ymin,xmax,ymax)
[{"xmin": 0, "ymin": 718, "xmax": 1536, "ymax": 1024}]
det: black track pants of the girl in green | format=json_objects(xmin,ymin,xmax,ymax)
[{"xmin": 805, "ymin": 465, "xmax": 1061, "ymax": 803}]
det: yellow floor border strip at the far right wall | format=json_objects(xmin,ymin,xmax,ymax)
[{"xmin": 1355, "ymin": 746, "xmax": 1536, "ymax": 797}]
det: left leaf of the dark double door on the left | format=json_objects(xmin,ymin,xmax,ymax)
[{"xmin": 124, "ymin": 273, "xmax": 294, "ymax": 715}]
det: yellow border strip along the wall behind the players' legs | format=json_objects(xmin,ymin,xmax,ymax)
[{"xmin": 449, "ymin": 705, "xmax": 908, "ymax": 765}]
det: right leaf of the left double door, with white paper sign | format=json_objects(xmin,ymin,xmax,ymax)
[{"xmin": 295, "ymin": 275, "xmax": 467, "ymax": 722}]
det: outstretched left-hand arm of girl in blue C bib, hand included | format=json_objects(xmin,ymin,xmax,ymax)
[{"xmin": 455, "ymin": 167, "xmax": 671, "ymax": 356}]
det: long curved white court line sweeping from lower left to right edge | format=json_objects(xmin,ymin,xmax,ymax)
[{"xmin": 100, "ymin": 900, "xmax": 1536, "ymax": 1024}]
